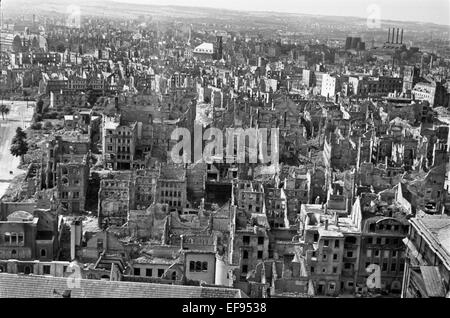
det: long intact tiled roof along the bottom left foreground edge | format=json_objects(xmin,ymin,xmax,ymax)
[{"xmin": 0, "ymin": 274, "xmax": 246, "ymax": 298}]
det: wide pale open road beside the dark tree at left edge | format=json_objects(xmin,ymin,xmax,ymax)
[{"xmin": 0, "ymin": 101, "xmax": 34, "ymax": 198}]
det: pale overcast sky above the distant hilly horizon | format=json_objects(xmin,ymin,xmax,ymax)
[{"xmin": 114, "ymin": 0, "xmax": 450, "ymax": 25}]
